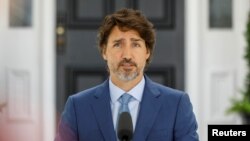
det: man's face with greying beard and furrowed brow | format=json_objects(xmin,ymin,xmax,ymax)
[{"xmin": 103, "ymin": 26, "xmax": 150, "ymax": 81}]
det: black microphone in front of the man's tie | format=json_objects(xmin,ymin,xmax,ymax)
[{"xmin": 117, "ymin": 112, "xmax": 133, "ymax": 141}]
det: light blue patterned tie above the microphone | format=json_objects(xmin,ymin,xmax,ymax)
[{"xmin": 119, "ymin": 93, "xmax": 133, "ymax": 115}]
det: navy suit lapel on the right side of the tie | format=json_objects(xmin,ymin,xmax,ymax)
[{"xmin": 133, "ymin": 77, "xmax": 162, "ymax": 141}]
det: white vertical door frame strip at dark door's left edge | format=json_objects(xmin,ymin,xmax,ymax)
[{"xmin": 40, "ymin": 0, "xmax": 56, "ymax": 141}]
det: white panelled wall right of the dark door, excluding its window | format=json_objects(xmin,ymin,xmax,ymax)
[{"xmin": 185, "ymin": 0, "xmax": 249, "ymax": 141}]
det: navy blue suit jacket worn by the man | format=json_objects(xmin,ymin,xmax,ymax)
[{"xmin": 55, "ymin": 76, "xmax": 199, "ymax": 141}]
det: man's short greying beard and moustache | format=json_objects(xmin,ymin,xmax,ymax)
[{"xmin": 112, "ymin": 59, "xmax": 140, "ymax": 82}]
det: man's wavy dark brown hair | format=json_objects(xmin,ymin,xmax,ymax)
[{"xmin": 97, "ymin": 8, "xmax": 155, "ymax": 65}]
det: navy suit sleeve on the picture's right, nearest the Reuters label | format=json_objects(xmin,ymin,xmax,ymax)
[{"xmin": 174, "ymin": 94, "xmax": 199, "ymax": 141}]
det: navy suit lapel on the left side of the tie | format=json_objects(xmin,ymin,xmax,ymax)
[{"xmin": 92, "ymin": 81, "xmax": 116, "ymax": 141}]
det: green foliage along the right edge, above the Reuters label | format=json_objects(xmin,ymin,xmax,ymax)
[{"xmin": 227, "ymin": 15, "xmax": 250, "ymax": 114}]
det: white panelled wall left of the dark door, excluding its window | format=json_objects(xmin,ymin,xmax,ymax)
[{"xmin": 0, "ymin": 0, "xmax": 56, "ymax": 141}]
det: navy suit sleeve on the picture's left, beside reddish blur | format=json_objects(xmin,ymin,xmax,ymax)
[{"xmin": 55, "ymin": 97, "xmax": 78, "ymax": 141}]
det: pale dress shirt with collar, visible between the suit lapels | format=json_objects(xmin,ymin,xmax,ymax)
[{"xmin": 109, "ymin": 77, "xmax": 145, "ymax": 130}]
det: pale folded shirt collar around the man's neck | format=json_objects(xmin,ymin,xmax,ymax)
[{"xmin": 109, "ymin": 77, "xmax": 145, "ymax": 103}]
